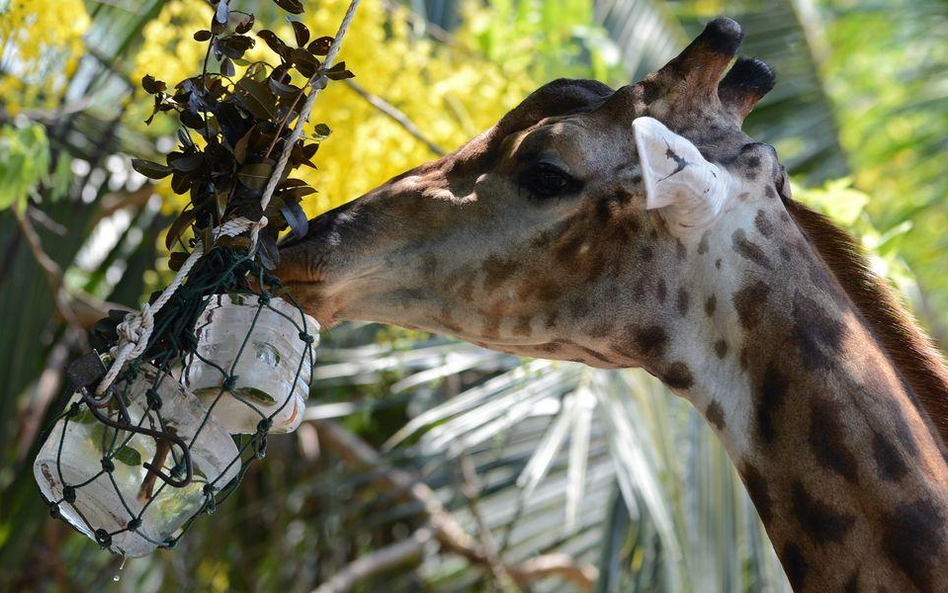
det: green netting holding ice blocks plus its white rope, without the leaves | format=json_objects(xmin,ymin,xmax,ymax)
[{"xmin": 34, "ymin": 0, "xmax": 359, "ymax": 556}]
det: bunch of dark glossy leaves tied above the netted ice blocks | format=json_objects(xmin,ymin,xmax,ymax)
[{"xmin": 132, "ymin": 0, "xmax": 353, "ymax": 269}]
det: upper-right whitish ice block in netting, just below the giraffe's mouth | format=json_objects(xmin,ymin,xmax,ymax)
[{"xmin": 184, "ymin": 293, "xmax": 319, "ymax": 434}]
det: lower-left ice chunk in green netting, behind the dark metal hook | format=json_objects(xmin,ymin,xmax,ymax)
[{"xmin": 33, "ymin": 355, "xmax": 240, "ymax": 557}]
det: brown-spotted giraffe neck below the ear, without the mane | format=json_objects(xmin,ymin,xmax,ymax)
[{"xmin": 672, "ymin": 202, "xmax": 948, "ymax": 591}]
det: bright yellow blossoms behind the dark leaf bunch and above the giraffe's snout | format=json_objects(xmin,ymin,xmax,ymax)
[{"xmin": 129, "ymin": 0, "xmax": 535, "ymax": 215}]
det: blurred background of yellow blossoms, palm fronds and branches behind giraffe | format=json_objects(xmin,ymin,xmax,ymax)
[{"xmin": 0, "ymin": 0, "xmax": 948, "ymax": 591}]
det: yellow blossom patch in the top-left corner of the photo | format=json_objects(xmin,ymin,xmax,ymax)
[{"xmin": 0, "ymin": 0, "xmax": 90, "ymax": 113}]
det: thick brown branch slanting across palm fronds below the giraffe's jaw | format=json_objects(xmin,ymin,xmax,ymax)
[{"xmin": 313, "ymin": 420, "xmax": 598, "ymax": 592}]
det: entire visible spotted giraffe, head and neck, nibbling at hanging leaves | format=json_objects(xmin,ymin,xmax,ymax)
[{"xmin": 278, "ymin": 19, "xmax": 948, "ymax": 591}]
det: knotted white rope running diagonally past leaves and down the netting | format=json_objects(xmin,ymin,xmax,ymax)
[{"xmin": 95, "ymin": 0, "xmax": 359, "ymax": 395}]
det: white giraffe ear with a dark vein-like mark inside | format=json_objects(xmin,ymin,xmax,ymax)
[{"xmin": 632, "ymin": 117, "xmax": 731, "ymax": 231}]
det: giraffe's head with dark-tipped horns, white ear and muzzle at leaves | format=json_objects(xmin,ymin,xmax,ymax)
[{"xmin": 277, "ymin": 19, "xmax": 787, "ymax": 376}]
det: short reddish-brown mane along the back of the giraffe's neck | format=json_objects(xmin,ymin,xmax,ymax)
[{"xmin": 783, "ymin": 198, "xmax": 948, "ymax": 445}]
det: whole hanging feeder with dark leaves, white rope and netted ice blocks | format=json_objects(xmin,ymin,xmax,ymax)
[{"xmin": 33, "ymin": 0, "xmax": 359, "ymax": 557}]
